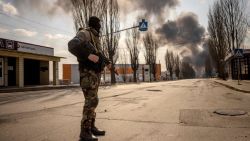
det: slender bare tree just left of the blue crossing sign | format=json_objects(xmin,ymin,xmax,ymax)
[{"xmin": 126, "ymin": 24, "xmax": 140, "ymax": 82}]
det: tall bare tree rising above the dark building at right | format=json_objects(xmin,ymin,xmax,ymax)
[{"xmin": 221, "ymin": 0, "xmax": 248, "ymax": 53}]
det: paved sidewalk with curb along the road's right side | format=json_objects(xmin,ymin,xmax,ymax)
[{"xmin": 214, "ymin": 79, "xmax": 250, "ymax": 93}]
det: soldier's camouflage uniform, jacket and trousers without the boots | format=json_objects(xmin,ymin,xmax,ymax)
[{"xmin": 77, "ymin": 28, "xmax": 104, "ymax": 139}]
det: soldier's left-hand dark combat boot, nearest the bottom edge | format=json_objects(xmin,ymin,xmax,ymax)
[{"xmin": 79, "ymin": 121, "xmax": 98, "ymax": 141}]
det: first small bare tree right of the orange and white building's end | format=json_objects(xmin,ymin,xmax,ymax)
[{"xmin": 165, "ymin": 50, "xmax": 175, "ymax": 80}]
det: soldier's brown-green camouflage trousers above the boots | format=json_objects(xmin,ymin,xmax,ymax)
[{"xmin": 80, "ymin": 69, "xmax": 101, "ymax": 129}]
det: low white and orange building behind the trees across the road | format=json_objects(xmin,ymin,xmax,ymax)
[{"xmin": 63, "ymin": 64, "xmax": 161, "ymax": 84}]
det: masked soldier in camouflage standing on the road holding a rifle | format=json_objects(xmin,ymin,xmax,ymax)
[{"xmin": 77, "ymin": 16, "xmax": 110, "ymax": 141}]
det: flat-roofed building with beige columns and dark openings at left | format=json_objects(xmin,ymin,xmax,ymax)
[{"xmin": 0, "ymin": 38, "xmax": 61, "ymax": 87}]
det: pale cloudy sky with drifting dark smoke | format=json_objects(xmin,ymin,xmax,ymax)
[{"xmin": 0, "ymin": 0, "xmax": 250, "ymax": 78}]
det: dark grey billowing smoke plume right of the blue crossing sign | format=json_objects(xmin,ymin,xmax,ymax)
[{"xmin": 156, "ymin": 12, "xmax": 208, "ymax": 68}]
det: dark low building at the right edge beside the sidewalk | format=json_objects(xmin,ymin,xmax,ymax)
[{"xmin": 226, "ymin": 49, "xmax": 250, "ymax": 80}]
